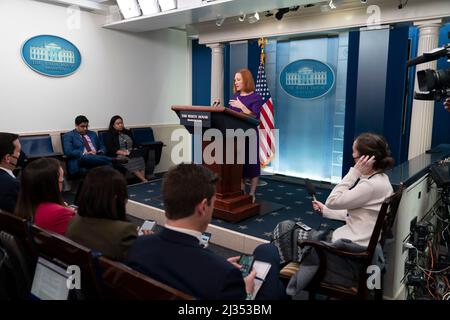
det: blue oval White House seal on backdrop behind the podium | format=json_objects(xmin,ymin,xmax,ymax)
[{"xmin": 280, "ymin": 59, "xmax": 335, "ymax": 100}]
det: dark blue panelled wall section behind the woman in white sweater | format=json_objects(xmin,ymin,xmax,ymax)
[{"xmin": 342, "ymin": 26, "xmax": 409, "ymax": 175}]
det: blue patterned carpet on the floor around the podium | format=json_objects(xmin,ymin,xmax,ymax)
[{"xmin": 128, "ymin": 178, "xmax": 342, "ymax": 240}]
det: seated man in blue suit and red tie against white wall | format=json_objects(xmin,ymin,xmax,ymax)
[{"xmin": 62, "ymin": 115, "xmax": 125, "ymax": 174}]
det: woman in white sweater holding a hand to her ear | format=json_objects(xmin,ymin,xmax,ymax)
[{"xmin": 313, "ymin": 133, "xmax": 394, "ymax": 246}]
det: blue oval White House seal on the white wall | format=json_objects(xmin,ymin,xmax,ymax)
[{"xmin": 22, "ymin": 35, "xmax": 81, "ymax": 77}]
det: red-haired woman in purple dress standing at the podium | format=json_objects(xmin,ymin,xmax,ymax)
[{"xmin": 229, "ymin": 69, "xmax": 263, "ymax": 202}]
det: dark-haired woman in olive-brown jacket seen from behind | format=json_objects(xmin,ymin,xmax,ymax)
[{"xmin": 66, "ymin": 166, "xmax": 148, "ymax": 261}]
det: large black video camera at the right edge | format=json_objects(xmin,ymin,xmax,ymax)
[{"xmin": 407, "ymin": 43, "xmax": 450, "ymax": 101}]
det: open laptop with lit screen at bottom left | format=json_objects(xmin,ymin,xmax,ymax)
[{"xmin": 31, "ymin": 257, "xmax": 69, "ymax": 300}]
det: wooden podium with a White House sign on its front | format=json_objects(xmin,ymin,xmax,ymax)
[{"xmin": 172, "ymin": 106, "xmax": 260, "ymax": 222}]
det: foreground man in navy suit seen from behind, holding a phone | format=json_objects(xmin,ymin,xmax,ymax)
[{"xmin": 127, "ymin": 164, "xmax": 284, "ymax": 299}]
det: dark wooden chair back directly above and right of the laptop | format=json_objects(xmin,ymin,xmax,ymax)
[{"xmin": 31, "ymin": 225, "xmax": 101, "ymax": 300}]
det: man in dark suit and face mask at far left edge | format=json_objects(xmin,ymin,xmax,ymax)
[{"xmin": 0, "ymin": 132, "xmax": 21, "ymax": 213}]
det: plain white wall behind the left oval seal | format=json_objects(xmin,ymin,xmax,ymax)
[{"xmin": 0, "ymin": 0, "xmax": 191, "ymax": 133}]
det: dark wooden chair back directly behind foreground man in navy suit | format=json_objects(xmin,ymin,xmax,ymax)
[{"xmin": 98, "ymin": 257, "xmax": 194, "ymax": 300}]
